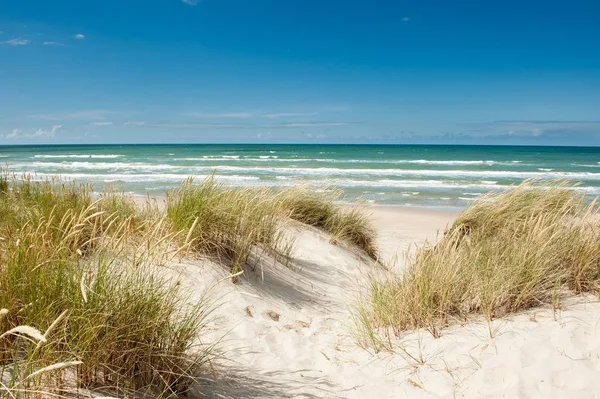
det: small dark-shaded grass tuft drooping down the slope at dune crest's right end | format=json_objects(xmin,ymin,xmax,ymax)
[{"xmin": 277, "ymin": 186, "xmax": 377, "ymax": 259}]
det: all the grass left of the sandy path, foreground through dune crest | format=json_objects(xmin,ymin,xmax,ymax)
[{"xmin": 0, "ymin": 172, "xmax": 376, "ymax": 398}]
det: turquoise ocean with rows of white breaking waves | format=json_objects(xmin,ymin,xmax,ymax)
[{"xmin": 0, "ymin": 144, "xmax": 600, "ymax": 208}]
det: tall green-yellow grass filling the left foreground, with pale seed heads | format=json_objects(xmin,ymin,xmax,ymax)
[{"xmin": 0, "ymin": 174, "xmax": 214, "ymax": 398}]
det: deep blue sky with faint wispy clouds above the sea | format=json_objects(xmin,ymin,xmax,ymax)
[{"xmin": 0, "ymin": 0, "xmax": 600, "ymax": 145}]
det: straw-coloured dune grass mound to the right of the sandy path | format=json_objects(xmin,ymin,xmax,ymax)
[{"xmin": 361, "ymin": 181, "xmax": 600, "ymax": 343}]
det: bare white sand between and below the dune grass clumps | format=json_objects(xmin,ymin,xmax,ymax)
[{"xmin": 168, "ymin": 208, "xmax": 600, "ymax": 398}]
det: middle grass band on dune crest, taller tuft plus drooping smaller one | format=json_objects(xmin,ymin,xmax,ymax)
[{"xmin": 166, "ymin": 176, "xmax": 377, "ymax": 274}]
